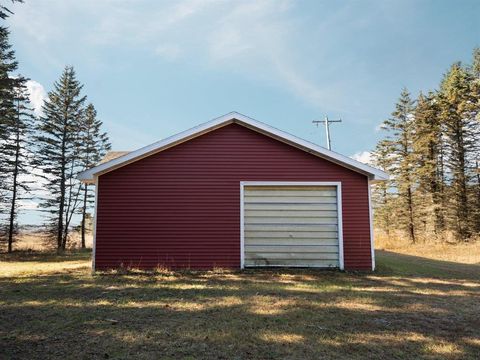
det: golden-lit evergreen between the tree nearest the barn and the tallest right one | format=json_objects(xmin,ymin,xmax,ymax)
[{"xmin": 413, "ymin": 92, "xmax": 445, "ymax": 235}]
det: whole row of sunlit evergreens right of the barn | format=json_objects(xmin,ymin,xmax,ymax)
[{"xmin": 373, "ymin": 48, "xmax": 480, "ymax": 243}]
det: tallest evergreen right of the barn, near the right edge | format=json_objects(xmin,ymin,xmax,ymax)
[{"xmin": 439, "ymin": 63, "xmax": 479, "ymax": 240}]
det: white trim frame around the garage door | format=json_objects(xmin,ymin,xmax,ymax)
[{"xmin": 240, "ymin": 181, "xmax": 344, "ymax": 270}]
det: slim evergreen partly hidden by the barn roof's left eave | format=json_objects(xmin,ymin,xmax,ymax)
[{"xmin": 80, "ymin": 104, "xmax": 111, "ymax": 248}]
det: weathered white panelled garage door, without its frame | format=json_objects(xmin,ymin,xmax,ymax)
[{"xmin": 243, "ymin": 185, "xmax": 342, "ymax": 267}]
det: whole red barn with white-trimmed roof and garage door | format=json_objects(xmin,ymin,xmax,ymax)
[{"xmin": 79, "ymin": 113, "xmax": 388, "ymax": 270}]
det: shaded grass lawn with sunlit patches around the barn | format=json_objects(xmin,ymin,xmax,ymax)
[{"xmin": 0, "ymin": 251, "xmax": 480, "ymax": 359}]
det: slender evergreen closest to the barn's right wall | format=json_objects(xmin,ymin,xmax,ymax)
[{"xmin": 383, "ymin": 89, "xmax": 416, "ymax": 243}]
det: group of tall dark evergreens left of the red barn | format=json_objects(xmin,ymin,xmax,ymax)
[{"xmin": 0, "ymin": 1, "xmax": 110, "ymax": 252}]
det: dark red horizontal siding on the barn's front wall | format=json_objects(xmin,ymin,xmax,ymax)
[{"xmin": 95, "ymin": 124, "xmax": 371, "ymax": 269}]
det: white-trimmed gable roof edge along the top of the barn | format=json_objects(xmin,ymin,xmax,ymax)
[{"xmin": 78, "ymin": 112, "xmax": 388, "ymax": 182}]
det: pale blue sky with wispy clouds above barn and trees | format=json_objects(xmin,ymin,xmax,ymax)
[{"xmin": 8, "ymin": 0, "xmax": 480, "ymax": 225}]
